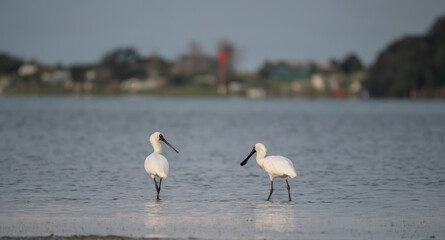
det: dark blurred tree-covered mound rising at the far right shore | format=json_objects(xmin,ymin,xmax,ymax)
[{"xmin": 365, "ymin": 13, "xmax": 445, "ymax": 98}]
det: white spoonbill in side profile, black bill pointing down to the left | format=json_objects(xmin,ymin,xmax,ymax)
[{"xmin": 240, "ymin": 143, "xmax": 297, "ymax": 201}]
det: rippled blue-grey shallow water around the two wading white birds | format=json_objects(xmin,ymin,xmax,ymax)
[{"xmin": 0, "ymin": 96, "xmax": 445, "ymax": 239}]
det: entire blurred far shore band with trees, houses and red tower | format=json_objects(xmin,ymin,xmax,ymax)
[{"xmin": 0, "ymin": 15, "xmax": 445, "ymax": 99}]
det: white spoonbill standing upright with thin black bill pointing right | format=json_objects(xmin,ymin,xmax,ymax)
[{"xmin": 144, "ymin": 132, "xmax": 179, "ymax": 200}]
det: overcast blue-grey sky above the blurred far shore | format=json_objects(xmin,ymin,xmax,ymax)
[{"xmin": 0, "ymin": 0, "xmax": 445, "ymax": 71}]
